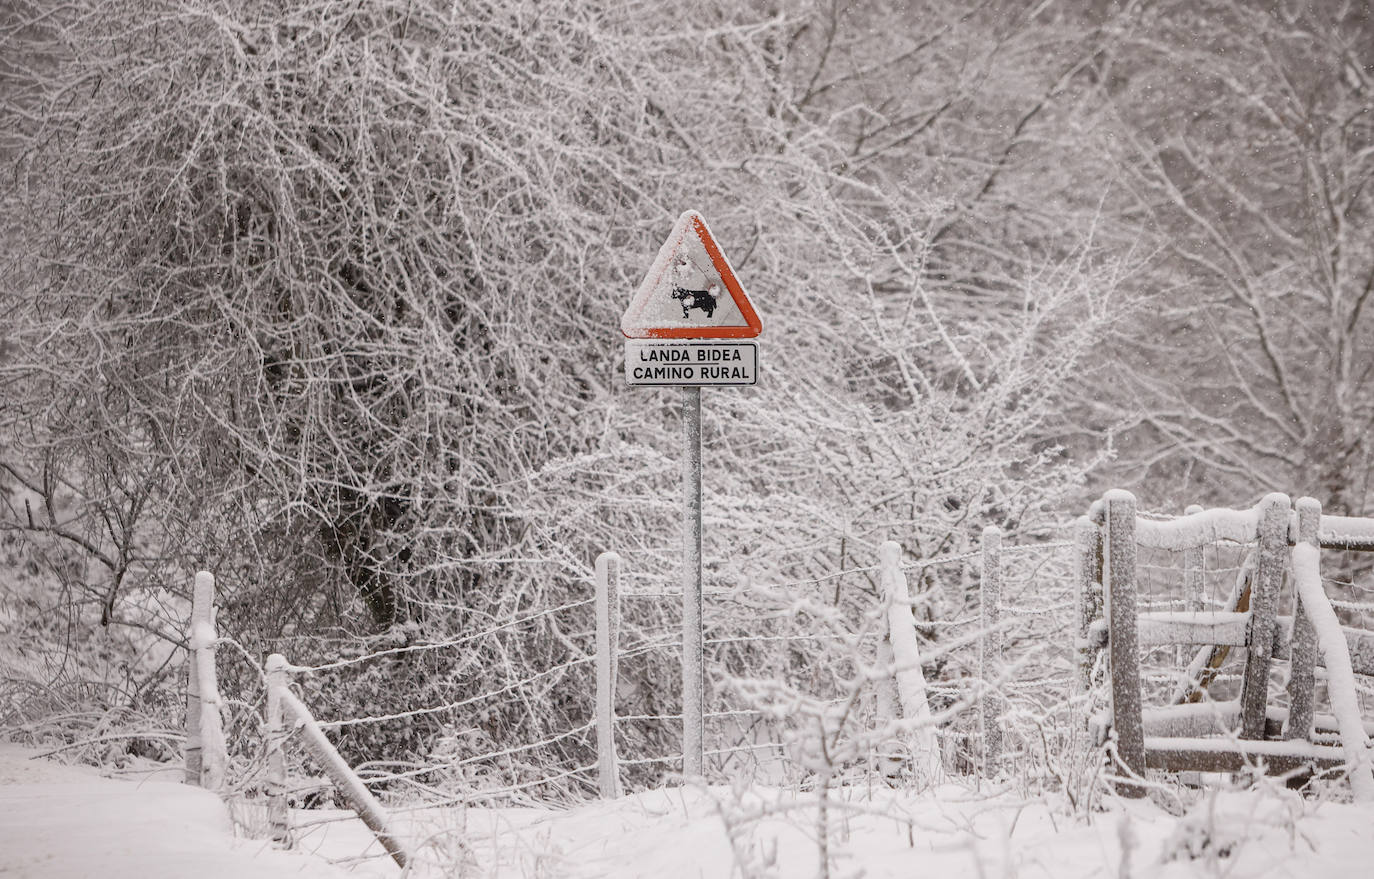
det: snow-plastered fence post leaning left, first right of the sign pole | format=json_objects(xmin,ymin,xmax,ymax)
[{"xmin": 878, "ymin": 540, "xmax": 940, "ymax": 780}]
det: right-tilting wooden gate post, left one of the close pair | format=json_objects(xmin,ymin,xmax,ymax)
[{"xmin": 1241, "ymin": 492, "xmax": 1293, "ymax": 739}]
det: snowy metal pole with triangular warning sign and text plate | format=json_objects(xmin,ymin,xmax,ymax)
[{"xmin": 620, "ymin": 210, "xmax": 763, "ymax": 776}]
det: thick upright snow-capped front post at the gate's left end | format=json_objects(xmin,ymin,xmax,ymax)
[{"xmin": 1102, "ymin": 489, "xmax": 1145, "ymax": 797}]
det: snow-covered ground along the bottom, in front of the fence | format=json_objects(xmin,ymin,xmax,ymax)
[{"xmin": 0, "ymin": 744, "xmax": 1374, "ymax": 879}]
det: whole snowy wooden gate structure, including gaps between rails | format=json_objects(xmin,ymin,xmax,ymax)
[{"xmin": 1079, "ymin": 492, "xmax": 1374, "ymax": 799}]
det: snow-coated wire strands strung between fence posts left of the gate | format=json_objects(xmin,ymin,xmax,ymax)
[{"xmin": 185, "ymin": 524, "xmax": 1074, "ymax": 830}]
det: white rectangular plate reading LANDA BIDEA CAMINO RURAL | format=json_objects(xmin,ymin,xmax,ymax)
[{"xmin": 625, "ymin": 339, "xmax": 758, "ymax": 387}]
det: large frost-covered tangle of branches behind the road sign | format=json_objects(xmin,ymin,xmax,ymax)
[{"xmin": 0, "ymin": 0, "xmax": 1116, "ymax": 769}]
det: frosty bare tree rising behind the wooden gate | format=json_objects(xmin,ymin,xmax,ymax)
[{"xmin": 1077, "ymin": 0, "xmax": 1374, "ymax": 515}]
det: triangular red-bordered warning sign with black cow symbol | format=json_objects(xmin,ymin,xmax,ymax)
[{"xmin": 620, "ymin": 210, "xmax": 763, "ymax": 339}]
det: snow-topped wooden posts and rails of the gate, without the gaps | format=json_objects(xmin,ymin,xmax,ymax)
[{"xmin": 1076, "ymin": 490, "xmax": 1374, "ymax": 799}]
